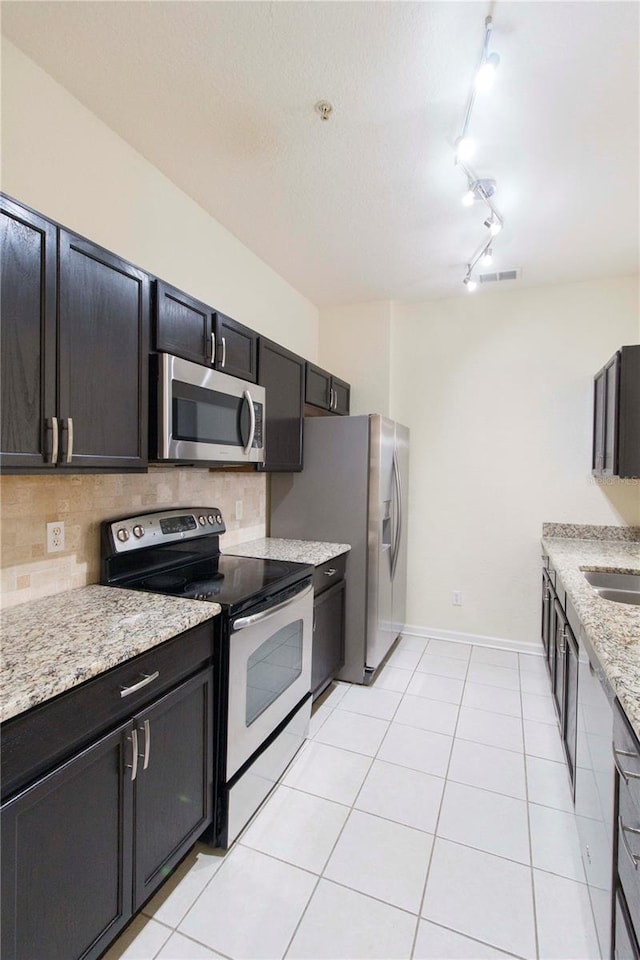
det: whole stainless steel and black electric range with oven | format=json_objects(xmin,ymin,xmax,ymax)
[{"xmin": 101, "ymin": 507, "xmax": 313, "ymax": 848}]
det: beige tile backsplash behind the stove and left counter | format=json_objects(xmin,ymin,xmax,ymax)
[{"xmin": 0, "ymin": 467, "xmax": 267, "ymax": 607}]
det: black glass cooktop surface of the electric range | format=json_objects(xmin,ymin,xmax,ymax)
[{"xmin": 122, "ymin": 554, "xmax": 313, "ymax": 614}]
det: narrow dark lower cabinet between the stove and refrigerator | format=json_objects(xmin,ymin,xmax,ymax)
[{"xmin": 311, "ymin": 556, "xmax": 346, "ymax": 700}]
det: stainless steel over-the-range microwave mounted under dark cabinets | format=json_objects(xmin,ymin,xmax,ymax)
[{"xmin": 152, "ymin": 353, "xmax": 265, "ymax": 463}]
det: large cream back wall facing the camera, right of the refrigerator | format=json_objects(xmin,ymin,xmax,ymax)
[{"xmin": 320, "ymin": 277, "xmax": 640, "ymax": 644}]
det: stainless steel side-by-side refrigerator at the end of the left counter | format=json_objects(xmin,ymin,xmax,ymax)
[{"xmin": 270, "ymin": 414, "xmax": 409, "ymax": 683}]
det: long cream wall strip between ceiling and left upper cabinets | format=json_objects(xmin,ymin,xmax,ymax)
[{"xmin": 2, "ymin": 40, "xmax": 318, "ymax": 360}]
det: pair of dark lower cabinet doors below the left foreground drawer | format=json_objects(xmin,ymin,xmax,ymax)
[{"xmin": 1, "ymin": 668, "xmax": 213, "ymax": 960}]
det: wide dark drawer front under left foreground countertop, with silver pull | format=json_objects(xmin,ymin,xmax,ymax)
[{"xmin": 2, "ymin": 622, "xmax": 213, "ymax": 798}]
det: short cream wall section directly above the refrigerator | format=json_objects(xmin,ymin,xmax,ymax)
[{"xmin": 319, "ymin": 301, "xmax": 392, "ymax": 416}]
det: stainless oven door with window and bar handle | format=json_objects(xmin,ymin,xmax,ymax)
[{"xmin": 225, "ymin": 580, "xmax": 313, "ymax": 781}]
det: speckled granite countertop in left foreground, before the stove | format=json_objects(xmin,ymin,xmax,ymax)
[{"xmin": 0, "ymin": 585, "xmax": 221, "ymax": 721}]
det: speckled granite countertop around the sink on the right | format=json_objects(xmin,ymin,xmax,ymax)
[{"xmin": 542, "ymin": 537, "xmax": 640, "ymax": 739}]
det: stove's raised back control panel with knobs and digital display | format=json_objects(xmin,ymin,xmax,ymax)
[{"xmin": 105, "ymin": 507, "xmax": 226, "ymax": 554}]
